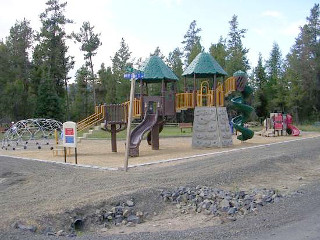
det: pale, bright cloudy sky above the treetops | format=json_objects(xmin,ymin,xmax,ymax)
[{"xmin": 0, "ymin": 0, "xmax": 319, "ymax": 78}]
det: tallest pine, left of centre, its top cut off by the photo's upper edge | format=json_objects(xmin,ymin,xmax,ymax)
[{"xmin": 32, "ymin": 0, "xmax": 73, "ymax": 120}]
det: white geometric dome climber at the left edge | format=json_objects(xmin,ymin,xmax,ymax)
[{"xmin": 2, "ymin": 118, "xmax": 62, "ymax": 150}]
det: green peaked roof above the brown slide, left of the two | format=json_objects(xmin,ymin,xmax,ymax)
[{"xmin": 140, "ymin": 56, "xmax": 179, "ymax": 83}]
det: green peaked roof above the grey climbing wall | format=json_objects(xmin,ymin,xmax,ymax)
[{"xmin": 182, "ymin": 52, "xmax": 228, "ymax": 78}]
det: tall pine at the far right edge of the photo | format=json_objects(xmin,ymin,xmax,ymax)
[{"xmin": 285, "ymin": 4, "xmax": 320, "ymax": 121}]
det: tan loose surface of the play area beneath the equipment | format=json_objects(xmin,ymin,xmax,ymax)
[{"xmin": 0, "ymin": 132, "xmax": 320, "ymax": 169}]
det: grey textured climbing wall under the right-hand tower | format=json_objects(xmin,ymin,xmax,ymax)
[{"xmin": 192, "ymin": 107, "xmax": 232, "ymax": 148}]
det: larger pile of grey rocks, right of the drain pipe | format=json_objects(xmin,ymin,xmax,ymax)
[{"xmin": 161, "ymin": 186, "xmax": 282, "ymax": 220}]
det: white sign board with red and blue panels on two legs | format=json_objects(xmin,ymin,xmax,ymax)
[{"xmin": 63, "ymin": 122, "xmax": 78, "ymax": 164}]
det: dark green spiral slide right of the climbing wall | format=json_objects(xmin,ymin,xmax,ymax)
[{"xmin": 231, "ymin": 97, "xmax": 254, "ymax": 141}]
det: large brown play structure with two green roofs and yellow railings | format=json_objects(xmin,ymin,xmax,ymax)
[{"xmin": 78, "ymin": 53, "xmax": 253, "ymax": 156}]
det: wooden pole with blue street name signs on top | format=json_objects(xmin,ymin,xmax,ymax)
[{"xmin": 124, "ymin": 68, "xmax": 144, "ymax": 172}]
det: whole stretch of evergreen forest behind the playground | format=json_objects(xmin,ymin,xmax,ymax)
[{"xmin": 0, "ymin": 0, "xmax": 320, "ymax": 123}]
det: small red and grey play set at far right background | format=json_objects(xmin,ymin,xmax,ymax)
[{"xmin": 258, "ymin": 113, "xmax": 300, "ymax": 137}]
